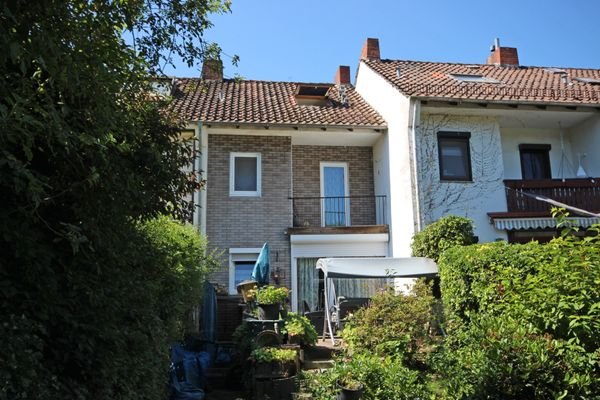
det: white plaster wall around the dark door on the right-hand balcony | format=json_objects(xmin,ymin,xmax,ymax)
[{"xmin": 501, "ymin": 128, "xmax": 577, "ymax": 179}]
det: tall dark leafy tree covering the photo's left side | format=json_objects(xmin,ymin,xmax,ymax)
[{"xmin": 0, "ymin": 0, "xmax": 229, "ymax": 399}]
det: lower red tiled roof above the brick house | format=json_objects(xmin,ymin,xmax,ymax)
[{"xmin": 172, "ymin": 78, "xmax": 385, "ymax": 127}]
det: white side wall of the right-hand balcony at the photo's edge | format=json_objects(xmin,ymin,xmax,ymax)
[{"xmin": 569, "ymin": 116, "xmax": 600, "ymax": 177}]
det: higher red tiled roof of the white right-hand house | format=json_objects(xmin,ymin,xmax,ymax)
[{"xmin": 364, "ymin": 60, "xmax": 600, "ymax": 105}]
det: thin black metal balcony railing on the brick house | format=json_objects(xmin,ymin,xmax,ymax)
[{"xmin": 290, "ymin": 195, "xmax": 387, "ymax": 227}]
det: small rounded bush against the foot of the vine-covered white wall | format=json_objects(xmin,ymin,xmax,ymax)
[{"xmin": 411, "ymin": 215, "xmax": 476, "ymax": 261}]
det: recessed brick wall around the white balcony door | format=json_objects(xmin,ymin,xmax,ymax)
[{"xmin": 292, "ymin": 146, "xmax": 375, "ymax": 226}]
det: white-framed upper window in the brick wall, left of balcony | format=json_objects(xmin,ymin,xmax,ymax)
[{"xmin": 229, "ymin": 153, "xmax": 261, "ymax": 197}]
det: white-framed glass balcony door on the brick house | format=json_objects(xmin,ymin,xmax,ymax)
[{"xmin": 321, "ymin": 162, "xmax": 350, "ymax": 226}]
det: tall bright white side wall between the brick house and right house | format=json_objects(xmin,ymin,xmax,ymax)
[{"xmin": 356, "ymin": 62, "xmax": 416, "ymax": 257}]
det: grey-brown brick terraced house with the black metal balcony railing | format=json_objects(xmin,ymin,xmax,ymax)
[{"xmin": 172, "ymin": 63, "xmax": 389, "ymax": 330}]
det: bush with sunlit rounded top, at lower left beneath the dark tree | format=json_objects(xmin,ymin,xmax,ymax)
[{"xmin": 0, "ymin": 217, "xmax": 214, "ymax": 399}]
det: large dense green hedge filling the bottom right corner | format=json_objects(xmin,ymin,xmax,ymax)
[{"xmin": 439, "ymin": 228, "xmax": 600, "ymax": 399}]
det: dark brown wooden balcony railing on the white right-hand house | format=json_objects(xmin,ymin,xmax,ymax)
[{"xmin": 504, "ymin": 178, "xmax": 600, "ymax": 212}]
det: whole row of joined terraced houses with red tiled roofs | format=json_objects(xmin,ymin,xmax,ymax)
[{"xmin": 172, "ymin": 39, "xmax": 600, "ymax": 336}]
